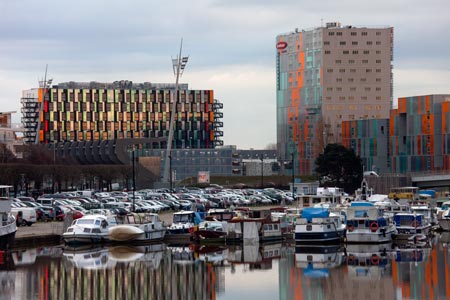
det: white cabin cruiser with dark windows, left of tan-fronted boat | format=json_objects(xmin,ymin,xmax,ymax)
[{"xmin": 62, "ymin": 215, "xmax": 117, "ymax": 244}]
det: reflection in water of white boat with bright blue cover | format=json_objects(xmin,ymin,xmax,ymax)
[{"xmin": 295, "ymin": 245, "xmax": 345, "ymax": 278}]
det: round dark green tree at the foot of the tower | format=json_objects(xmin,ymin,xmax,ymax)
[{"xmin": 315, "ymin": 144, "xmax": 363, "ymax": 193}]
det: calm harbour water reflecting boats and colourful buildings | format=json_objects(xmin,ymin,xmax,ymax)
[{"xmin": 0, "ymin": 233, "xmax": 450, "ymax": 300}]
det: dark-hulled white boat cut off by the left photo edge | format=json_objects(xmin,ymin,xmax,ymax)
[{"xmin": 0, "ymin": 198, "xmax": 17, "ymax": 250}]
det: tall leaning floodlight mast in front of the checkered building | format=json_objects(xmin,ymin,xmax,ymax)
[{"xmin": 163, "ymin": 39, "xmax": 189, "ymax": 183}]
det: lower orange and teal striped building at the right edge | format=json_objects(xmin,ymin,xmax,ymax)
[{"xmin": 342, "ymin": 94, "xmax": 450, "ymax": 173}]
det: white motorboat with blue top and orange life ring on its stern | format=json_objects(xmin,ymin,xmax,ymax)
[{"xmin": 346, "ymin": 201, "xmax": 397, "ymax": 243}]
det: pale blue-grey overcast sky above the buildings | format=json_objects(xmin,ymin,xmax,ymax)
[{"xmin": 0, "ymin": 0, "xmax": 450, "ymax": 149}]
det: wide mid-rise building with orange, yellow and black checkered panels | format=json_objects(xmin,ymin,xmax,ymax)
[{"xmin": 21, "ymin": 81, "xmax": 223, "ymax": 163}]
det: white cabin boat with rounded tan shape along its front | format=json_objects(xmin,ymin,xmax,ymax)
[{"xmin": 108, "ymin": 213, "xmax": 166, "ymax": 242}]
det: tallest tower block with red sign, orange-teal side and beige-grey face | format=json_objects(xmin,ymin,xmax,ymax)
[{"xmin": 276, "ymin": 23, "xmax": 393, "ymax": 174}]
